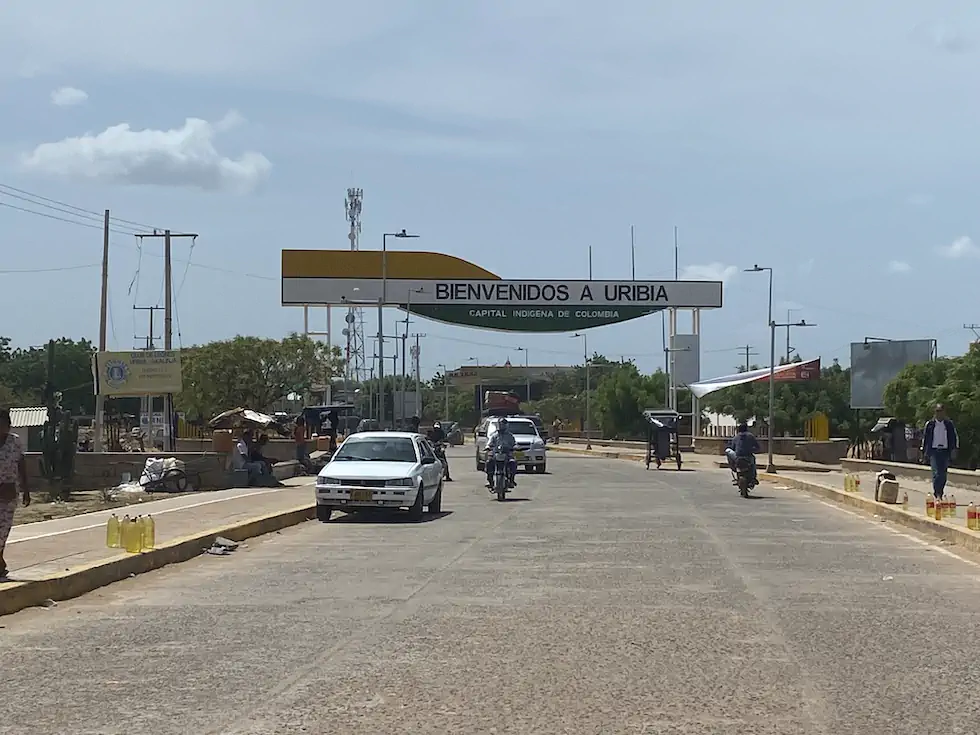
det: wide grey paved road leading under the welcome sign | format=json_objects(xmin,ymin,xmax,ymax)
[{"xmin": 0, "ymin": 450, "xmax": 980, "ymax": 735}]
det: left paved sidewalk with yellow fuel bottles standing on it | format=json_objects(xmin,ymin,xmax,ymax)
[{"xmin": 0, "ymin": 477, "xmax": 315, "ymax": 594}]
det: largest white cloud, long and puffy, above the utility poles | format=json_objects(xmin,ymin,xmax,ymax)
[{"xmin": 23, "ymin": 112, "xmax": 272, "ymax": 193}]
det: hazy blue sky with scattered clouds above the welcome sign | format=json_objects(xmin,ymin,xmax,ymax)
[{"xmin": 0, "ymin": 0, "xmax": 980, "ymax": 378}]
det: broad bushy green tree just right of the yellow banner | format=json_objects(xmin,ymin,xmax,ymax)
[{"xmin": 175, "ymin": 333, "xmax": 343, "ymax": 420}]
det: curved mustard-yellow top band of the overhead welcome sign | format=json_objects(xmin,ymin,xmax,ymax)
[{"xmin": 282, "ymin": 250, "xmax": 500, "ymax": 281}]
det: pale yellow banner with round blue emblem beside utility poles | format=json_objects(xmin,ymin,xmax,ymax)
[{"xmin": 94, "ymin": 350, "xmax": 183, "ymax": 396}]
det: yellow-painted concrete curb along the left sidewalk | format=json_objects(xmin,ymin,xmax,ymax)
[{"xmin": 0, "ymin": 503, "xmax": 316, "ymax": 615}]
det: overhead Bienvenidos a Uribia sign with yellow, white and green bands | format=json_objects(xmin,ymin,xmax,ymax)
[{"xmin": 282, "ymin": 250, "xmax": 722, "ymax": 332}]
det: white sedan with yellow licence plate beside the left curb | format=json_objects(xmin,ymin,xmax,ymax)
[{"xmin": 316, "ymin": 431, "xmax": 443, "ymax": 522}]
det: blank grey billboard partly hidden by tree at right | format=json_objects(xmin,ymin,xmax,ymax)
[{"xmin": 851, "ymin": 339, "xmax": 936, "ymax": 409}]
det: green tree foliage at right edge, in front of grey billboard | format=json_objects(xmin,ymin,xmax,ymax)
[{"xmin": 884, "ymin": 343, "xmax": 980, "ymax": 467}]
